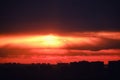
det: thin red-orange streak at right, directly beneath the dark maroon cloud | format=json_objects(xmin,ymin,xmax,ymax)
[{"xmin": 64, "ymin": 49, "xmax": 120, "ymax": 56}]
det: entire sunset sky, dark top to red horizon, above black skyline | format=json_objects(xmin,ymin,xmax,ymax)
[{"xmin": 0, "ymin": 0, "xmax": 120, "ymax": 63}]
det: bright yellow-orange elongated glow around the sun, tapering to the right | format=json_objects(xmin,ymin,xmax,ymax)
[{"xmin": 0, "ymin": 35, "xmax": 101, "ymax": 48}]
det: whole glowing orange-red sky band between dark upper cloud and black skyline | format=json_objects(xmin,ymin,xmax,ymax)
[{"xmin": 0, "ymin": 32, "xmax": 120, "ymax": 63}]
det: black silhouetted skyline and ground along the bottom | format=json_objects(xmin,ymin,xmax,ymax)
[{"xmin": 0, "ymin": 61, "xmax": 120, "ymax": 80}]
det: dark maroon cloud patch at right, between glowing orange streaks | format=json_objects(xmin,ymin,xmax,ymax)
[{"xmin": 67, "ymin": 38, "xmax": 120, "ymax": 51}]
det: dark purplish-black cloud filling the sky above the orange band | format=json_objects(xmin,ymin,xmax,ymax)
[{"xmin": 0, "ymin": 0, "xmax": 120, "ymax": 34}]
